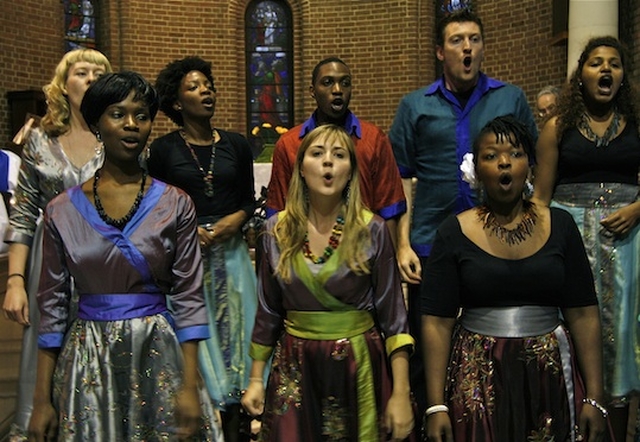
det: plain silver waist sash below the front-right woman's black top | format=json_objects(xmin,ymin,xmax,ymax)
[{"xmin": 460, "ymin": 305, "xmax": 560, "ymax": 338}]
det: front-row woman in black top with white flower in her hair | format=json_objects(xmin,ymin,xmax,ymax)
[{"xmin": 421, "ymin": 116, "xmax": 607, "ymax": 442}]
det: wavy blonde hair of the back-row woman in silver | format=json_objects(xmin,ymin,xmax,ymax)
[{"xmin": 40, "ymin": 49, "xmax": 111, "ymax": 137}]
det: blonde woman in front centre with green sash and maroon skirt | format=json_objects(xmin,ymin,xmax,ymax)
[{"xmin": 242, "ymin": 125, "xmax": 413, "ymax": 442}]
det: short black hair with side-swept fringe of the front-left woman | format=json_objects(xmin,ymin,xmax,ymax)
[{"xmin": 80, "ymin": 71, "xmax": 158, "ymax": 127}]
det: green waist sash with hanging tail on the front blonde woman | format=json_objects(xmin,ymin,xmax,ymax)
[{"xmin": 284, "ymin": 310, "xmax": 379, "ymax": 442}]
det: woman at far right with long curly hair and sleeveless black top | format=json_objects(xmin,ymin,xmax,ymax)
[{"xmin": 534, "ymin": 36, "xmax": 640, "ymax": 441}]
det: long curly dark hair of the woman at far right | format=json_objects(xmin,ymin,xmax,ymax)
[{"xmin": 556, "ymin": 36, "xmax": 640, "ymax": 138}]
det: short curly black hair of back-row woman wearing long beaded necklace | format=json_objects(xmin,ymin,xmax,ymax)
[{"xmin": 156, "ymin": 56, "xmax": 215, "ymax": 126}]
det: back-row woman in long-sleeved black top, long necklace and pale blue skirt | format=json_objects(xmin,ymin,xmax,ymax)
[{"xmin": 147, "ymin": 57, "xmax": 257, "ymax": 442}]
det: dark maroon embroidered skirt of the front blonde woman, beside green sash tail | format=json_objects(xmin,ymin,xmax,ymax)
[{"xmin": 258, "ymin": 328, "xmax": 404, "ymax": 442}]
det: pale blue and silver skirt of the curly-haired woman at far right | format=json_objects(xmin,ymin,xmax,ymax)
[{"xmin": 552, "ymin": 183, "xmax": 640, "ymax": 400}]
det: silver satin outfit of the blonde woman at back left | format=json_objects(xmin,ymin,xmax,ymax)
[{"xmin": 5, "ymin": 128, "xmax": 104, "ymax": 439}]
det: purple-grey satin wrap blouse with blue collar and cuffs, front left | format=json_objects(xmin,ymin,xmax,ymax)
[{"xmin": 38, "ymin": 180, "xmax": 208, "ymax": 348}]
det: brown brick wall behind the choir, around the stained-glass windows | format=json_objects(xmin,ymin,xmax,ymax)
[{"xmin": 0, "ymin": 0, "xmax": 640, "ymax": 148}]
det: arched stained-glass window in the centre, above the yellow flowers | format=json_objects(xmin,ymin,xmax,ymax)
[{"xmin": 245, "ymin": 0, "xmax": 293, "ymax": 156}]
